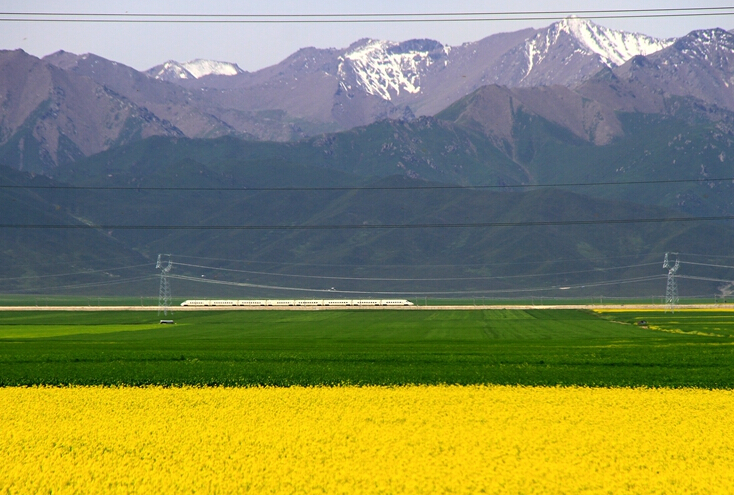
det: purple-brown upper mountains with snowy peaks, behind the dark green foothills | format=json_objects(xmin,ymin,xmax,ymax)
[{"xmin": 0, "ymin": 18, "xmax": 734, "ymax": 172}]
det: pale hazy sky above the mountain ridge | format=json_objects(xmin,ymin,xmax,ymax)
[{"xmin": 0, "ymin": 0, "xmax": 734, "ymax": 71}]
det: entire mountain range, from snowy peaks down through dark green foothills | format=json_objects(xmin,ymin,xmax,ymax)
[{"xmin": 0, "ymin": 18, "xmax": 734, "ymax": 294}]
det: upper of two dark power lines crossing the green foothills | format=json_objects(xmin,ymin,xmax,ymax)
[{"xmin": 0, "ymin": 177, "xmax": 734, "ymax": 192}]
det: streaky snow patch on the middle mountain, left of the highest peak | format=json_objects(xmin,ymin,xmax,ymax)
[{"xmin": 338, "ymin": 39, "xmax": 448, "ymax": 100}]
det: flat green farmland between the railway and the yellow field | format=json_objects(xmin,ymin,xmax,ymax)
[{"xmin": 0, "ymin": 309, "xmax": 734, "ymax": 388}]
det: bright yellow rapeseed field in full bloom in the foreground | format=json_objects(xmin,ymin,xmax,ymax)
[{"xmin": 0, "ymin": 386, "xmax": 734, "ymax": 494}]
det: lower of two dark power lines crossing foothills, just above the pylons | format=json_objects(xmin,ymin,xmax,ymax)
[{"xmin": 0, "ymin": 215, "xmax": 734, "ymax": 230}]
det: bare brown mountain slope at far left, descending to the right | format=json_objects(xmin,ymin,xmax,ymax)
[{"xmin": 0, "ymin": 50, "xmax": 183, "ymax": 172}]
